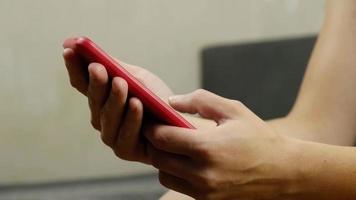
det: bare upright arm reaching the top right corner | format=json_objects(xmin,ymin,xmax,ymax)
[{"xmin": 269, "ymin": 0, "xmax": 356, "ymax": 145}]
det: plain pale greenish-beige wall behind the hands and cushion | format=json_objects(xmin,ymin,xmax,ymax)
[{"xmin": 0, "ymin": 0, "xmax": 324, "ymax": 198}]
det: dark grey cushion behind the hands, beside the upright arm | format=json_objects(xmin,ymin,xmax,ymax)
[{"xmin": 202, "ymin": 36, "xmax": 316, "ymax": 119}]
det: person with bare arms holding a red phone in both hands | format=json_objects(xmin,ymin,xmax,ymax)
[{"xmin": 63, "ymin": 0, "xmax": 356, "ymax": 200}]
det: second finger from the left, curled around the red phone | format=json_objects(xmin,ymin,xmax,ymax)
[{"xmin": 87, "ymin": 63, "xmax": 109, "ymax": 130}]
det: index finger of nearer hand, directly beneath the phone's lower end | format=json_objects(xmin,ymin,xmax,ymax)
[{"xmin": 144, "ymin": 125, "xmax": 201, "ymax": 156}]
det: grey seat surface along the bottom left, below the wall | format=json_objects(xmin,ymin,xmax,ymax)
[{"xmin": 0, "ymin": 174, "xmax": 167, "ymax": 200}]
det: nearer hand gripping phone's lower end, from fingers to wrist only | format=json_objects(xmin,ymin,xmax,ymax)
[{"xmin": 145, "ymin": 90, "xmax": 300, "ymax": 200}]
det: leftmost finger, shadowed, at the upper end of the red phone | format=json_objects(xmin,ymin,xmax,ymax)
[{"xmin": 63, "ymin": 48, "xmax": 88, "ymax": 95}]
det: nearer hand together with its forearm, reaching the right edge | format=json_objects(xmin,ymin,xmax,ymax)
[{"xmin": 144, "ymin": 90, "xmax": 356, "ymax": 200}]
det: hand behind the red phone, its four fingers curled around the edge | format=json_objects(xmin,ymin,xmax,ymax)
[{"xmin": 63, "ymin": 40, "xmax": 173, "ymax": 164}]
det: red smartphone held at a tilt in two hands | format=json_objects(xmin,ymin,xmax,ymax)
[{"xmin": 64, "ymin": 37, "xmax": 194, "ymax": 129}]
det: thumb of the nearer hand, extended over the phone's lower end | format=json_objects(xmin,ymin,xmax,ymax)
[{"xmin": 169, "ymin": 89, "xmax": 245, "ymax": 123}]
